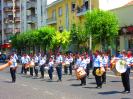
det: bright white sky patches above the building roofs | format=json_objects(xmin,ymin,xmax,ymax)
[{"xmin": 47, "ymin": 0, "xmax": 131, "ymax": 10}]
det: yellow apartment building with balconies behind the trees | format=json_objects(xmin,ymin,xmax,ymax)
[{"xmin": 46, "ymin": 0, "xmax": 99, "ymax": 31}]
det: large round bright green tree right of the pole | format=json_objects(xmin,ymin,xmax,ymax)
[{"xmin": 85, "ymin": 9, "xmax": 119, "ymax": 50}]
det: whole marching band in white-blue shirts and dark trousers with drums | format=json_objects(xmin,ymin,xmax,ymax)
[{"xmin": 0, "ymin": 51, "xmax": 133, "ymax": 93}]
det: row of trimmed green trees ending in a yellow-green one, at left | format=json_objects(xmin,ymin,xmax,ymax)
[{"xmin": 12, "ymin": 27, "xmax": 70, "ymax": 51}]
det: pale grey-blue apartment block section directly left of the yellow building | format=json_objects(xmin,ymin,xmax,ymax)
[{"xmin": 21, "ymin": 0, "xmax": 47, "ymax": 32}]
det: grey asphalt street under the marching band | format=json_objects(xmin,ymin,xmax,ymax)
[{"xmin": 0, "ymin": 63, "xmax": 133, "ymax": 99}]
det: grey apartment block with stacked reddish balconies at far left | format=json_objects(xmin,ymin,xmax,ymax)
[{"xmin": 1, "ymin": 0, "xmax": 21, "ymax": 44}]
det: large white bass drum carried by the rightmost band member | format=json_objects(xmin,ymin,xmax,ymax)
[{"xmin": 116, "ymin": 60, "xmax": 127, "ymax": 73}]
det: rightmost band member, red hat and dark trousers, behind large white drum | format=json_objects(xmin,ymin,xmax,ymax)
[{"xmin": 121, "ymin": 51, "xmax": 133, "ymax": 94}]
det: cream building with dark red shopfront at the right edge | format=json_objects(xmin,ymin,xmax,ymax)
[{"xmin": 111, "ymin": 1, "xmax": 133, "ymax": 50}]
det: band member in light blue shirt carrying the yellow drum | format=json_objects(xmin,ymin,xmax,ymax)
[{"xmin": 93, "ymin": 51, "xmax": 102, "ymax": 88}]
